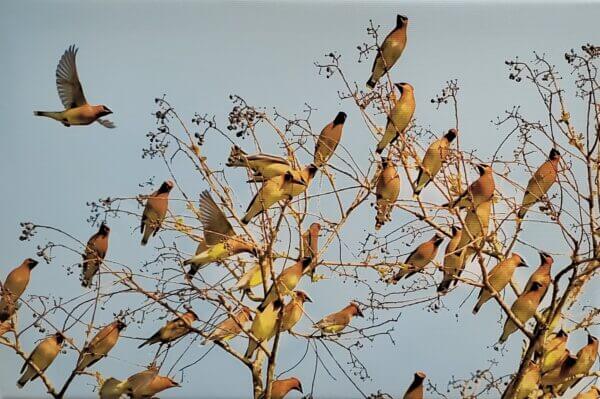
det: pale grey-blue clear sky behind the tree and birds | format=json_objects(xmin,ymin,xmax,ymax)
[{"xmin": 0, "ymin": 1, "xmax": 600, "ymax": 398}]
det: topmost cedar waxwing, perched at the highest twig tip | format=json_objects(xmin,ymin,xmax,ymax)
[{"xmin": 367, "ymin": 14, "xmax": 408, "ymax": 89}]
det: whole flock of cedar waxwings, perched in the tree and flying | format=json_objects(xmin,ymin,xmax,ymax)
[{"xmin": 0, "ymin": 11, "xmax": 600, "ymax": 399}]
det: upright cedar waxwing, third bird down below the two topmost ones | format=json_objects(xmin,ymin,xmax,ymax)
[{"xmin": 375, "ymin": 158, "xmax": 400, "ymax": 230}]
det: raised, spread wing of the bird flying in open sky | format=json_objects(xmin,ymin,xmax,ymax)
[{"xmin": 56, "ymin": 45, "xmax": 87, "ymax": 109}]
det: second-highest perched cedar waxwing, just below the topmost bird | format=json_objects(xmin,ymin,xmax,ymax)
[{"xmin": 376, "ymin": 82, "xmax": 416, "ymax": 154}]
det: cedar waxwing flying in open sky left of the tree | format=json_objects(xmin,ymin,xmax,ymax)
[{"xmin": 33, "ymin": 45, "xmax": 115, "ymax": 129}]
